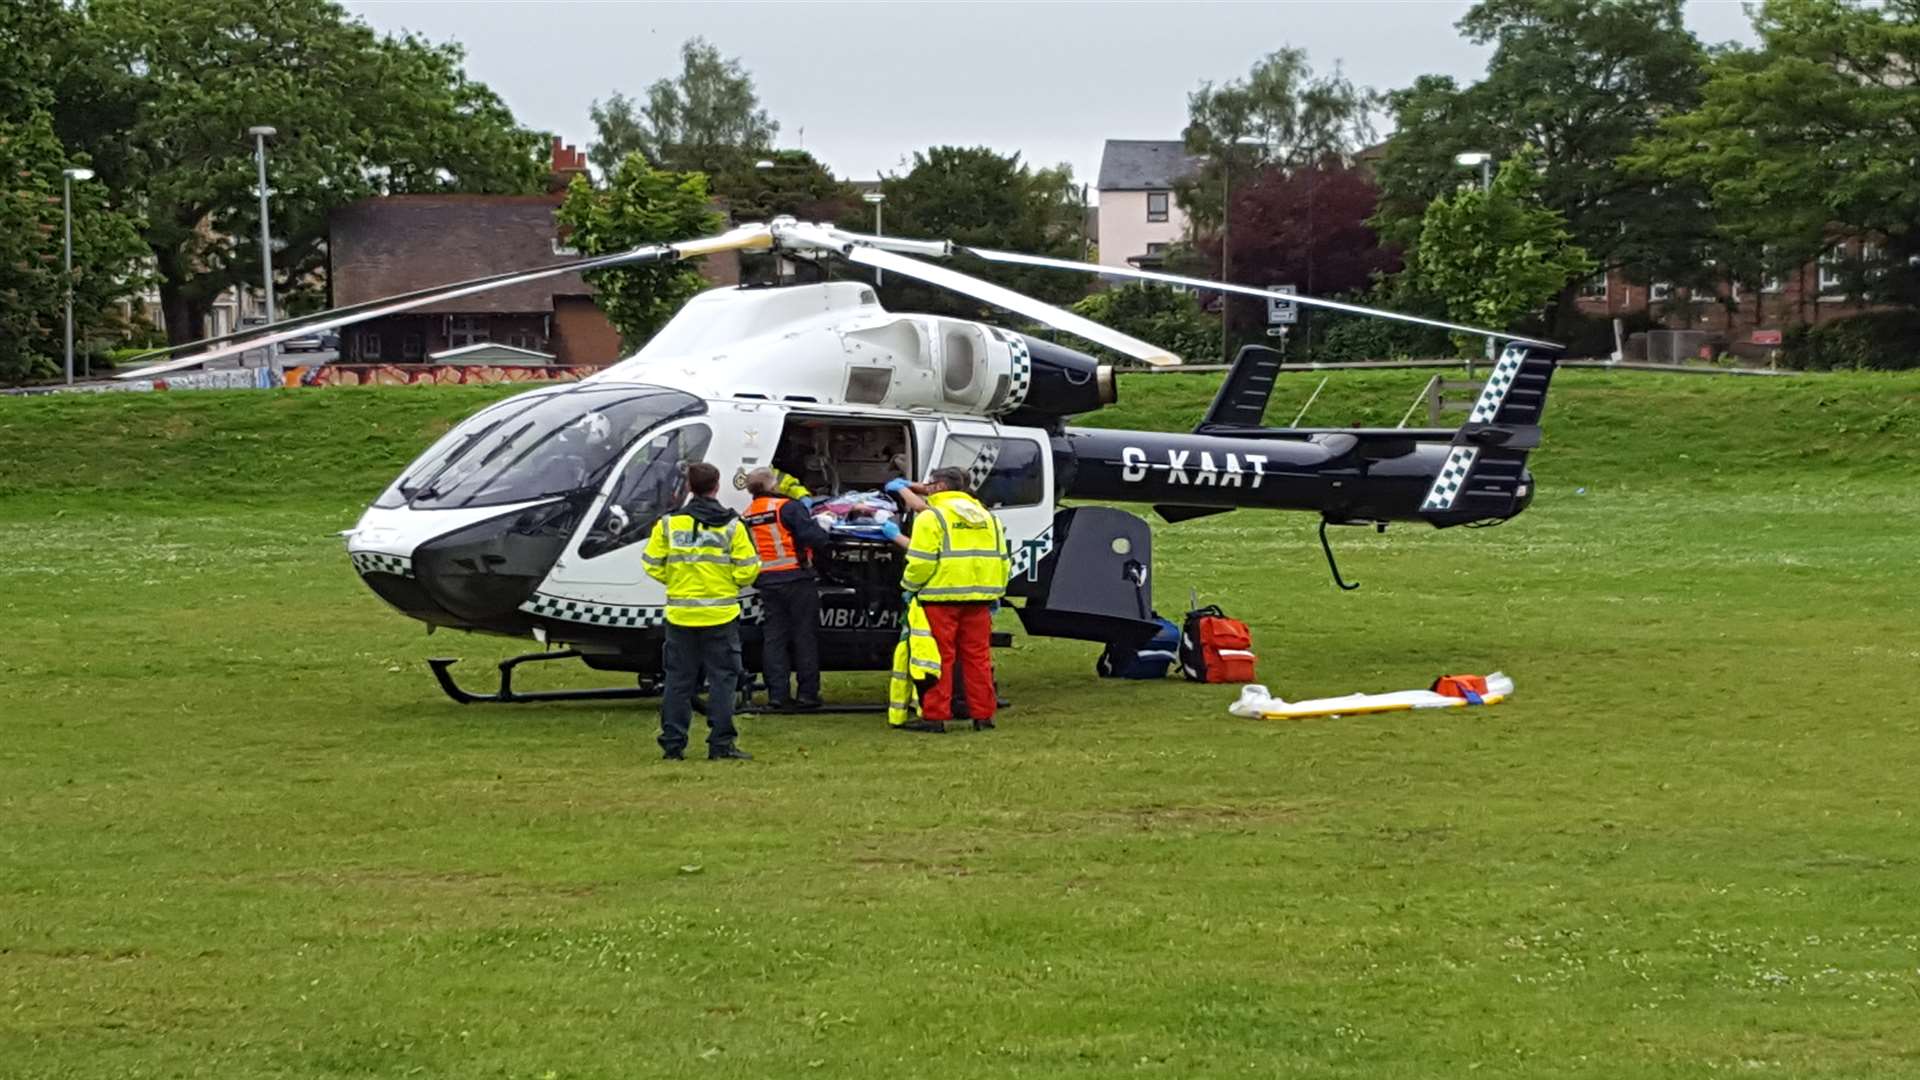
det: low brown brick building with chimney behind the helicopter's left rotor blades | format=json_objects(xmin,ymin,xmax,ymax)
[{"xmin": 328, "ymin": 138, "xmax": 739, "ymax": 365}]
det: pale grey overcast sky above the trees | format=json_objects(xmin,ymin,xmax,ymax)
[{"xmin": 346, "ymin": 0, "xmax": 1751, "ymax": 195}]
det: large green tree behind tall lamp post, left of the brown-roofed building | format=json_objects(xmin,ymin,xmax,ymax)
[{"xmin": 56, "ymin": 0, "xmax": 545, "ymax": 342}]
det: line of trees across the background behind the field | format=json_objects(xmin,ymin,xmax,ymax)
[{"xmin": 0, "ymin": 0, "xmax": 1920, "ymax": 380}]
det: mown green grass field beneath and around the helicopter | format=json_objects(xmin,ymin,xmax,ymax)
[{"xmin": 0, "ymin": 373, "xmax": 1920, "ymax": 1080}]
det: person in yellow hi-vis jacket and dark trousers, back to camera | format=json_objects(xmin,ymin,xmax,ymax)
[{"xmin": 639, "ymin": 461, "xmax": 760, "ymax": 761}]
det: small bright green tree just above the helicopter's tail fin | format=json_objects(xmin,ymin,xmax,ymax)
[{"xmin": 1413, "ymin": 150, "xmax": 1594, "ymax": 356}]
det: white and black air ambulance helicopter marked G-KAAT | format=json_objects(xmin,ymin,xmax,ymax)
[{"xmin": 123, "ymin": 217, "xmax": 1559, "ymax": 701}]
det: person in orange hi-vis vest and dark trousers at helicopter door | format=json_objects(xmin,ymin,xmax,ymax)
[{"xmin": 741, "ymin": 469, "xmax": 831, "ymax": 709}]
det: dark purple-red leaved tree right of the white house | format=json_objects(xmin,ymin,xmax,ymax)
[{"xmin": 1196, "ymin": 161, "xmax": 1400, "ymax": 331}]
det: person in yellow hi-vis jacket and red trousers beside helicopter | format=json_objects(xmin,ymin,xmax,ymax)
[{"xmin": 885, "ymin": 469, "xmax": 1008, "ymax": 732}]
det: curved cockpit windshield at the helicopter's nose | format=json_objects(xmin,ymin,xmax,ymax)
[{"xmin": 376, "ymin": 386, "xmax": 705, "ymax": 509}]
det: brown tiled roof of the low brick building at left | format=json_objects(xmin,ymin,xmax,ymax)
[{"xmin": 328, "ymin": 194, "xmax": 593, "ymax": 315}]
